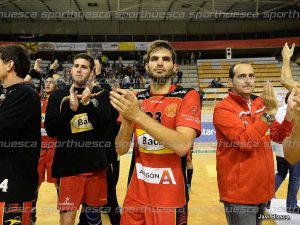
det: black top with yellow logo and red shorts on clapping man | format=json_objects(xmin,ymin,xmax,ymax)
[{"xmin": 45, "ymin": 87, "xmax": 113, "ymax": 211}]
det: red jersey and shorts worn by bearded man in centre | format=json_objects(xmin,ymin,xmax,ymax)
[{"xmin": 121, "ymin": 85, "xmax": 201, "ymax": 225}]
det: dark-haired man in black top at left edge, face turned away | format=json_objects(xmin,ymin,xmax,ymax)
[{"xmin": 0, "ymin": 45, "xmax": 41, "ymax": 225}]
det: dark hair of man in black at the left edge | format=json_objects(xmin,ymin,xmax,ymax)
[{"xmin": 0, "ymin": 44, "xmax": 31, "ymax": 78}]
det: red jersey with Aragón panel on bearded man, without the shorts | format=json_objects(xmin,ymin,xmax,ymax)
[{"xmin": 127, "ymin": 85, "xmax": 201, "ymax": 208}]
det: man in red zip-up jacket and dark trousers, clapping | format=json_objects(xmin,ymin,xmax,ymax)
[{"xmin": 213, "ymin": 63, "xmax": 295, "ymax": 225}]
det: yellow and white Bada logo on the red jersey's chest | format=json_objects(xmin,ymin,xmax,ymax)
[{"xmin": 136, "ymin": 129, "xmax": 173, "ymax": 154}]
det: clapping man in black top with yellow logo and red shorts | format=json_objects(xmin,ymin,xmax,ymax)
[{"xmin": 45, "ymin": 53, "xmax": 113, "ymax": 225}]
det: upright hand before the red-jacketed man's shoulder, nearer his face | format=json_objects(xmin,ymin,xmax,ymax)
[{"xmin": 261, "ymin": 81, "xmax": 278, "ymax": 115}]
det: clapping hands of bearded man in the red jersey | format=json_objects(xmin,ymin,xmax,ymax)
[{"xmin": 110, "ymin": 88, "xmax": 141, "ymax": 122}]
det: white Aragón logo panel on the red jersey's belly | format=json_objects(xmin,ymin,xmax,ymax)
[{"xmin": 135, "ymin": 163, "xmax": 176, "ymax": 184}]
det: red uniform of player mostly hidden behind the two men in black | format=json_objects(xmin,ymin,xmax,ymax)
[{"xmin": 38, "ymin": 98, "xmax": 57, "ymax": 184}]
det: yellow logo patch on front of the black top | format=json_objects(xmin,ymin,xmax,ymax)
[{"xmin": 70, "ymin": 113, "xmax": 94, "ymax": 134}]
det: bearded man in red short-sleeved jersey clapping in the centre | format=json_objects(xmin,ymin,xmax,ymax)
[{"xmin": 110, "ymin": 41, "xmax": 200, "ymax": 225}]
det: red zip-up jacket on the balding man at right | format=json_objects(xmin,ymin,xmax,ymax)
[{"xmin": 213, "ymin": 92, "xmax": 293, "ymax": 204}]
